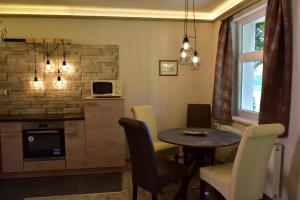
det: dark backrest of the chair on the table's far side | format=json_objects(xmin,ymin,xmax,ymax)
[{"xmin": 186, "ymin": 104, "xmax": 211, "ymax": 128}]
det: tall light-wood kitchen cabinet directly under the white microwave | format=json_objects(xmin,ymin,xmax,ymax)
[{"xmin": 84, "ymin": 98, "xmax": 125, "ymax": 168}]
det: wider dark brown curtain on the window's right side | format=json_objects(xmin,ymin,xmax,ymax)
[{"xmin": 259, "ymin": 0, "xmax": 292, "ymax": 136}]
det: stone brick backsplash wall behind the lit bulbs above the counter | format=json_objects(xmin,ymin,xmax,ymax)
[{"xmin": 0, "ymin": 43, "xmax": 119, "ymax": 114}]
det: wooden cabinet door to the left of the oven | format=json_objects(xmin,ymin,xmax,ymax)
[{"xmin": 1, "ymin": 132, "xmax": 23, "ymax": 172}]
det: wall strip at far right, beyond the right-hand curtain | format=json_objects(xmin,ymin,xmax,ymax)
[{"xmin": 280, "ymin": 0, "xmax": 300, "ymax": 200}]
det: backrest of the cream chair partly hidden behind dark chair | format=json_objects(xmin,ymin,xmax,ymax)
[{"xmin": 131, "ymin": 105, "xmax": 158, "ymax": 141}]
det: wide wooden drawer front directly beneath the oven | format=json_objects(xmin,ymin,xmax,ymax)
[{"xmin": 24, "ymin": 160, "xmax": 66, "ymax": 172}]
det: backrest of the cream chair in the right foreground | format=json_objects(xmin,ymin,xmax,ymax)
[{"xmin": 230, "ymin": 124, "xmax": 284, "ymax": 200}]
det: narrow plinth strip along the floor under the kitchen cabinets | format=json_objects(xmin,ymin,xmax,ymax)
[{"xmin": 0, "ymin": 167, "xmax": 126, "ymax": 180}]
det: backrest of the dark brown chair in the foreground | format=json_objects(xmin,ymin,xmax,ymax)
[{"xmin": 119, "ymin": 117, "xmax": 158, "ymax": 191}]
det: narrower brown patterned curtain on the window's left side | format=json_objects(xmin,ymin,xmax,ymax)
[{"xmin": 212, "ymin": 19, "xmax": 233, "ymax": 123}]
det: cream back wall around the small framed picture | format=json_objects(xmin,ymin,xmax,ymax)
[{"xmin": 1, "ymin": 17, "xmax": 216, "ymax": 129}]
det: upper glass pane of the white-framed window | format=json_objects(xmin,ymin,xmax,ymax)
[{"xmin": 242, "ymin": 17, "xmax": 265, "ymax": 53}]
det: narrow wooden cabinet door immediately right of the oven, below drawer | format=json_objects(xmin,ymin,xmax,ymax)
[{"xmin": 65, "ymin": 130, "xmax": 85, "ymax": 169}]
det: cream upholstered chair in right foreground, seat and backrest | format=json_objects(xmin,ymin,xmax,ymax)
[{"xmin": 200, "ymin": 124, "xmax": 284, "ymax": 200}]
